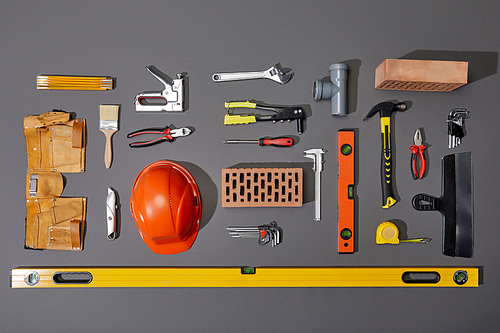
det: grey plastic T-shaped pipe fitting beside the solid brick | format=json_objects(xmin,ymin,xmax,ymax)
[{"xmin": 313, "ymin": 64, "xmax": 349, "ymax": 116}]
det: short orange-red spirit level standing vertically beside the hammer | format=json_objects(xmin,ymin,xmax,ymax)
[{"xmin": 337, "ymin": 130, "xmax": 355, "ymax": 253}]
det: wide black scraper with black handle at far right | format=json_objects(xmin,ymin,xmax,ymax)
[{"xmin": 412, "ymin": 152, "xmax": 473, "ymax": 258}]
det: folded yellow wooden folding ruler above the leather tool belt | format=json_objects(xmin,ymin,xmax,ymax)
[{"xmin": 36, "ymin": 75, "xmax": 113, "ymax": 90}]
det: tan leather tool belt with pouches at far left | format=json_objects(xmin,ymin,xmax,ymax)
[{"xmin": 24, "ymin": 110, "xmax": 87, "ymax": 251}]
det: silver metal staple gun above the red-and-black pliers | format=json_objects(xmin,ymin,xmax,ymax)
[{"xmin": 134, "ymin": 66, "xmax": 184, "ymax": 112}]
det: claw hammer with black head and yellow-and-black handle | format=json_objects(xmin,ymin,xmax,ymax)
[{"xmin": 363, "ymin": 102, "xmax": 406, "ymax": 208}]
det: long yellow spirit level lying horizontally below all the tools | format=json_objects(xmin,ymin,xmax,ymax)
[{"xmin": 11, "ymin": 267, "xmax": 479, "ymax": 288}]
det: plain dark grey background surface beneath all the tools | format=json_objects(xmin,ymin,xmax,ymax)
[{"xmin": 0, "ymin": 0, "xmax": 500, "ymax": 332}]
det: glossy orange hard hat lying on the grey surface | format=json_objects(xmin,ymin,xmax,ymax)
[{"xmin": 130, "ymin": 160, "xmax": 201, "ymax": 254}]
